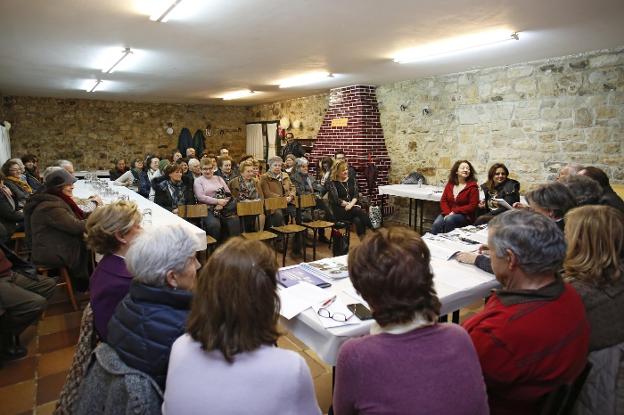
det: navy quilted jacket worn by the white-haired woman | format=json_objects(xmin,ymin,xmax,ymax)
[{"xmin": 107, "ymin": 282, "xmax": 191, "ymax": 390}]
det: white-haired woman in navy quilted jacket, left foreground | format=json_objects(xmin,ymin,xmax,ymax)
[{"xmin": 107, "ymin": 225, "xmax": 200, "ymax": 389}]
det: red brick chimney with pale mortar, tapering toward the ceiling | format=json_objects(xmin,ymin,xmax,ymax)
[{"xmin": 311, "ymin": 85, "xmax": 390, "ymax": 204}]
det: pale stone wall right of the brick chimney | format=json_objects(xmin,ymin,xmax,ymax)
[{"xmin": 377, "ymin": 46, "xmax": 624, "ymax": 191}]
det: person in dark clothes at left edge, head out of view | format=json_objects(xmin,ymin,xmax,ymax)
[{"xmin": 0, "ymin": 244, "xmax": 56, "ymax": 360}]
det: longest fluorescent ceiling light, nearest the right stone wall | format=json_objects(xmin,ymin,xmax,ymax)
[{"xmin": 394, "ymin": 29, "xmax": 519, "ymax": 63}]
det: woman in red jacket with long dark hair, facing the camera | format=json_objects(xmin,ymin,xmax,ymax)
[{"xmin": 431, "ymin": 160, "xmax": 479, "ymax": 235}]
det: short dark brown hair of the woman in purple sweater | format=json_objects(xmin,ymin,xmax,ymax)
[{"xmin": 348, "ymin": 227, "xmax": 440, "ymax": 326}]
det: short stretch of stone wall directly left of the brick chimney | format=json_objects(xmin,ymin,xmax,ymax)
[{"xmin": 247, "ymin": 94, "xmax": 329, "ymax": 140}]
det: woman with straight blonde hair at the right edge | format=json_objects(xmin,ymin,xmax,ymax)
[{"xmin": 563, "ymin": 205, "xmax": 624, "ymax": 351}]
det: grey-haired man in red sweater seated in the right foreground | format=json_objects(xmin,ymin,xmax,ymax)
[{"xmin": 463, "ymin": 210, "xmax": 589, "ymax": 414}]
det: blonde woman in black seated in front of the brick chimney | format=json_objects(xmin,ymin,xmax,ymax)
[{"xmin": 327, "ymin": 159, "xmax": 373, "ymax": 238}]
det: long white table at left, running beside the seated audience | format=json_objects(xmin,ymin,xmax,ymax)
[{"xmin": 74, "ymin": 180, "xmax": 207, "ymax": 251}]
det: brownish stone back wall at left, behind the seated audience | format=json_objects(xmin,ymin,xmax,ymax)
[{"xmin": 1, "ymin": 97, "xmax": 247, "ymax": 170}]
